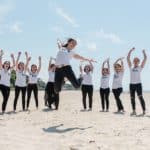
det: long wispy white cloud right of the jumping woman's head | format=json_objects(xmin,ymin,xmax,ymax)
[{"xmin": 96, "ymin": 28, "xmax": 123, "ymax": 44}]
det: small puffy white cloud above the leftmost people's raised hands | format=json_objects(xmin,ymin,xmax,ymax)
[{"xmin": 10, "ymin": 21, "xmax": 23, "ymax": 33}]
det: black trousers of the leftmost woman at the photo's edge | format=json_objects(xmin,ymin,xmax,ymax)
[{"xmin": 0, "ymin": 85, "xmax": 10, "ymax": 112}]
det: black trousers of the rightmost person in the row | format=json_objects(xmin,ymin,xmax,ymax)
[{"xmin": 130, "ymin": 83, "xmax": 146, "ymax": 111}]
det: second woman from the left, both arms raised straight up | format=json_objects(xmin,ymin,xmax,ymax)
[{"xmin": 14, "ymin": 52, "xmax": 31, "ymax": 111}]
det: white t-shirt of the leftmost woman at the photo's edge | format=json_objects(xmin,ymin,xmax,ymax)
[{"xmin": 0, "ymin": 69, "xmax": 11, "ymax": 87}]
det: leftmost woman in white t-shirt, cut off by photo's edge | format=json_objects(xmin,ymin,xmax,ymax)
[{"xmin": 0, "ymin": 50, "xmax": 15, "ymax": 114}]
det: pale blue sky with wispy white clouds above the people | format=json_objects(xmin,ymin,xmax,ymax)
[{"xmin": 0, "ymin": 0, "xmax": 150, "ymax": 90}]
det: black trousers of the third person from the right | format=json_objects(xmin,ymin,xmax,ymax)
[{"xmin": 100, "ymin": 88, "xmax": 110, "ymax": 110}]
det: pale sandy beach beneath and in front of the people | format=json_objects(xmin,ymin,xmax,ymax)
[{"xmin": 0, "ymin": 91, "xmax": 150, "ymax": 150}]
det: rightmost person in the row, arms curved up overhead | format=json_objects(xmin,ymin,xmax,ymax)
[{"xmin": 127, "ymin": 47, "xmax": 147, "ymax": 115}]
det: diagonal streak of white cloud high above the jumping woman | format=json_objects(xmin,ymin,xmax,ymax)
[{"xmin": 56, "ymin": 7, "xmax": 79, "ymax": 28}]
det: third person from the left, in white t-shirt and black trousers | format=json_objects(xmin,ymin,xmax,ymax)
[{"xmin": 27, "ymin": 57, "xmax": 41, "ymax": 110}]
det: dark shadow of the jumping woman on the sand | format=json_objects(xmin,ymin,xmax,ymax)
[{"xmin": 43, "ymin": 124, "xmax": 92, "ymax": 133}]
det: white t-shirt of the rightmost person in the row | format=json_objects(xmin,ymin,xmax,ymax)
[{"xmin": 130, "ymin": 67, "xmax": 142, "ymax": 84}]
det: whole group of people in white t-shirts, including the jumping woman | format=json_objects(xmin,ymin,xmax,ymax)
[{"xmin": 0, "ymin": 38, "xmax": 147, "ymax": 115}]
